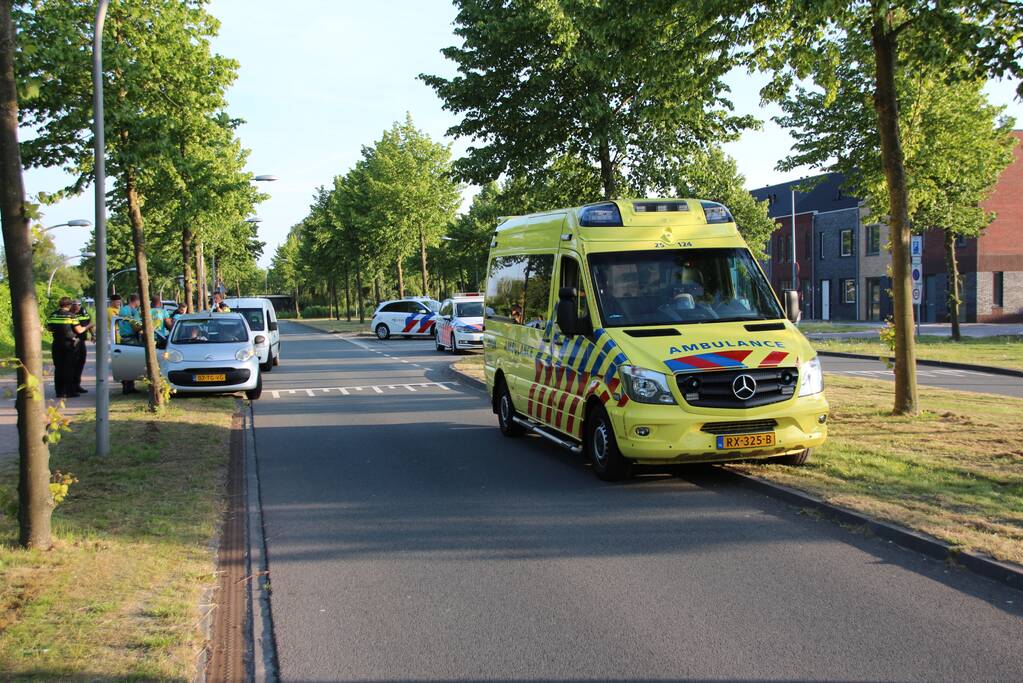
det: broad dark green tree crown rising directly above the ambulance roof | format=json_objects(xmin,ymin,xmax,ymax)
[{"xmin": 419, "ymin": 0, "xmax": 755, "ymax": 198}]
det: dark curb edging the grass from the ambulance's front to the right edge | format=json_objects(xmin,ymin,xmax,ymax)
[{"xmin": 718, "ymin": 467, "xmax": 1023, "ymax": 590}]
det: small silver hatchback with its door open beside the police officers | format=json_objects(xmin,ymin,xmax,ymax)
[{"xmin": 110, "ymin": 312, "xmax": 268, "ymax": 401}]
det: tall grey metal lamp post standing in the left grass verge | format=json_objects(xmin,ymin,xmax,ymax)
[{"xmin": 92, "ymin": 0, "xmax": 110, "ymax": 457}]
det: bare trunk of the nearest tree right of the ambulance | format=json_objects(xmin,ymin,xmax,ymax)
[{"xmin": 871, "ymin": 14, "xmax": 919, "ymax": 415}]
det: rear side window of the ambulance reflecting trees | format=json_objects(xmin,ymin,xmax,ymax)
[{"xmin": 487, "ymin": 254, "xmax": 554, "ymax": 328}]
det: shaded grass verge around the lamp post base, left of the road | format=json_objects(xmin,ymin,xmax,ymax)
[{"xmin": 0, "ymin": 397, "xmax": 235, "ymax": 681}]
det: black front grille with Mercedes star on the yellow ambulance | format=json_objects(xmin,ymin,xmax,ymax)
[{"xmin": 675, "ymin": 367, "xmax": 799, "ymax": 408}]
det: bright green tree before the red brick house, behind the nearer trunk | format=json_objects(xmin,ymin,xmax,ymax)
[{"xmin": 776, "ymin": 40, "xmax": 1016, "ymax": 340}]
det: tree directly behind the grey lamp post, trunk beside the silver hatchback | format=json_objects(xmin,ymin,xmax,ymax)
[{"xmin": 18, "ymin": 0, "xmax": 237, "ymax": 410}]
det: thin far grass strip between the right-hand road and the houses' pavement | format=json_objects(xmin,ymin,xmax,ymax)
[{"xmin": 810, "ymin": 335, "xmax": 1023, "ymax": 370}]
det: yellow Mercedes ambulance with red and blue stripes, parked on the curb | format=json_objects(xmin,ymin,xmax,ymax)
[{"xmin": 484, "ymin": 199, "xmax": 828, "ymax": 481}]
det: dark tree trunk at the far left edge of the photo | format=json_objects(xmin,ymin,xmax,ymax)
[{"xmin": 0, "ymin": 0, "xmax": 51, "ymax": 550}]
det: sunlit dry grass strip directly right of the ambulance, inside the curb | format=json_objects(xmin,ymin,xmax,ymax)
[{"xmin": 731, "ymin": 375, "xmax": 1023, "ymax": 564}]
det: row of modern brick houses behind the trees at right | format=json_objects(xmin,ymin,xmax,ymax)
[{"xmin": 751, "ymin": 131, "xmax": 1023, "ymax": 322}]
